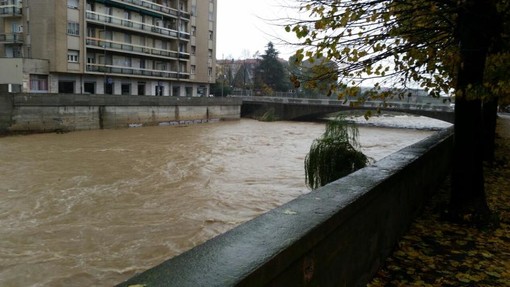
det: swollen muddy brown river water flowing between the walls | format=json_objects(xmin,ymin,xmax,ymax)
[{"xmin": 0, "ymin": 119, "xmax": 446, "ymax": 286}]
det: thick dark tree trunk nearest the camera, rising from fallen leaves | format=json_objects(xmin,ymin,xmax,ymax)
[{"xmin": 448, "ymin": 0, "xmax": 493, "ymax": 221}]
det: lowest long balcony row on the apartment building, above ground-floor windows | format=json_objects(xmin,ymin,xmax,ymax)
[{"xmin": 87, "ymin": 63, "xmax": 190, "ymax": 80}]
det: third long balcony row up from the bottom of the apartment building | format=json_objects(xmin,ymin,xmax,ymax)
[{"xmin": 87, "ymin": 11, "xmax": 190, "ymax": 40}]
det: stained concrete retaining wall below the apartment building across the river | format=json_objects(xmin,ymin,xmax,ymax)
[{"xmin": 0, "ymin": 93, "xmax": 242, "ymax": 133}]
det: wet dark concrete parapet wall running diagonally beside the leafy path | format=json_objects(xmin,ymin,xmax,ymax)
[{"xmin": 118, "ymin": 129, "xmax": 453, "ymax": 287}]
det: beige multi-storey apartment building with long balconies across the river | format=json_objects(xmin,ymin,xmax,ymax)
[{"xmin": 0, "ymin": 0, "xmax": 217, "ymax": 96}]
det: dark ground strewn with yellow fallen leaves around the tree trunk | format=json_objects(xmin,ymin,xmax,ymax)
[{"xmin": 367, "ymin": 117, "xmax": 510, "ymax": 287}]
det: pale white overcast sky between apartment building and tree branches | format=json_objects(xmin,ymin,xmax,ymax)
[{"xmin": 216, "ymin": 0, "xmax": 294, "ymax": 59}]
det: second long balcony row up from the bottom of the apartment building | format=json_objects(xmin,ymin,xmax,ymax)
[{"xmin": 86, "ymin": 37, "xmax": 190, "ymax": 60}]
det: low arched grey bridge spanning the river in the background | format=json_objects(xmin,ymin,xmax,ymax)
[{"xmin": 240, "ymin": 97, "xmax": 454, "ymax": 123}]
